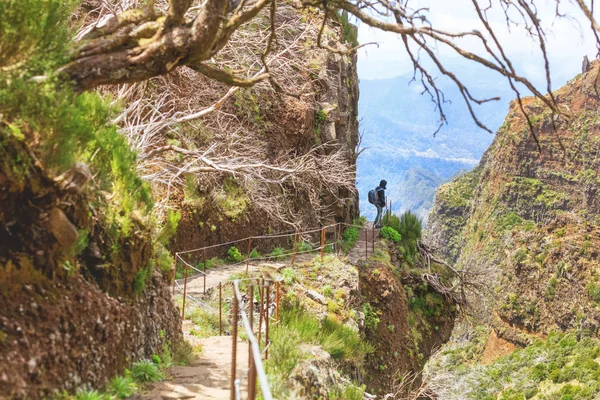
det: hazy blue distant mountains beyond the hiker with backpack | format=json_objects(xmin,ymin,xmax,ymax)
[{"xmin": 357, "ymin": 74, "xmax": 512, "ymax": 220}]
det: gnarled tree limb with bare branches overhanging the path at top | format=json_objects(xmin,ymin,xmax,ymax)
[{"xmin": 49, "ymin": 0, "xmax": 600, "ymax": 145}]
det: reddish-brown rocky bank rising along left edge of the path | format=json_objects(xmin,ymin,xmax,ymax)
[{"xmin": 0, "ymin": 134, "xmax": 182, "ymax": 399}]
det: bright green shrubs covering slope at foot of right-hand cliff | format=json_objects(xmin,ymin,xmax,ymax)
[{"xmin": 428, "ymin": 332, "xmax": 600, "ymax": 400}]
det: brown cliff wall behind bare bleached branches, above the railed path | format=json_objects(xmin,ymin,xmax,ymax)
[{"xmin": 171, "ymin": 11, "xmax": 359, "ymax": 256}]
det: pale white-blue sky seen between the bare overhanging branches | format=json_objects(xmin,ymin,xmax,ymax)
[{"xmin": 358, "ymin": 0, "xmax": 597, "ymax": 90}]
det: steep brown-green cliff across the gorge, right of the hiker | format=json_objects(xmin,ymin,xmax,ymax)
[{"xmin": 428, "ymin": 63, "xmax": 600, "ymax": 344}]
